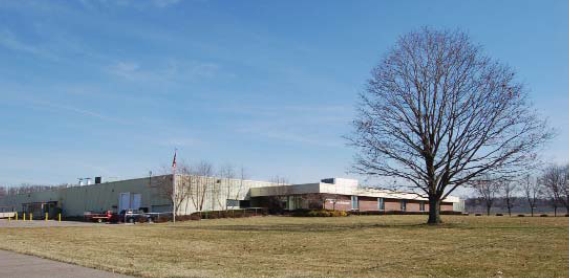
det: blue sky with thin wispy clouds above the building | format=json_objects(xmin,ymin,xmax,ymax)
[{"xmin": 0, "ymin": 0, "xmax": 569, "ymax": 188}]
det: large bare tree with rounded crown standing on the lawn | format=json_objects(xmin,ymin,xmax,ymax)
[{"xmin": 349, "ymin": 28, "xmax": 551, "ymax": 224}]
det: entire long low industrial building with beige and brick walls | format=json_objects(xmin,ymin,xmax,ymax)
[{"xmin": 0, "ymin": 175, "xmax": 464, "ymax": 217}]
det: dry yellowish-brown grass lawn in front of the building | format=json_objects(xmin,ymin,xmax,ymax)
[{"xmin": 0, "ymin": 216, "xmax": 568, "ymax": 277}]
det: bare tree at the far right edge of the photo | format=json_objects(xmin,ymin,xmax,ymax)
[{"xmin": 542, "ymin": 164, "xmax": 568, "ymax": 216}]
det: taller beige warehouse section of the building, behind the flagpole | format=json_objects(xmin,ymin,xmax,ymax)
[{"xmin": 0, "ymin": 175, "xmax": 273, "ymax": 217}]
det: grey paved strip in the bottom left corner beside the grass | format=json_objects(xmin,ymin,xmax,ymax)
[{"xmin": 0, "ymin": 250, "xmax": 126, "ymax": 278}]
